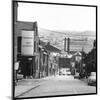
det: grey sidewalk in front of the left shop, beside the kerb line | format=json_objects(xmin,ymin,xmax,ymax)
[{"xmin": 15, "ymin": 76, "xmax": 52, "ymax": 97}]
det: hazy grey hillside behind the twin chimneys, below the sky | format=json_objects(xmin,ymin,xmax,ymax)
[{"xmin": 38, "ymin": 28, "xmax": 96, "ymax": 52}]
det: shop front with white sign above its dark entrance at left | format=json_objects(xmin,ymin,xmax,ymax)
[{"xmin": 17, "ymin": 24, "xmax": 39, "ymax": 78}]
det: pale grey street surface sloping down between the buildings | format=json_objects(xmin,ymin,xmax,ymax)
[{"xmin": 17, "ymin": 75, "xmax": 96, "ymax": 98}]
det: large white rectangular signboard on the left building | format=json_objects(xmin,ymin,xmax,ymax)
[{"xmin": 21, "ymin": 30, "xmax": 34, "ymax": 56}]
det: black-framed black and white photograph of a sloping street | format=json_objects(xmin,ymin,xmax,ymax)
[{"xmin": 12, "ymin": 0, "xmax": 97, "ymax": 100}]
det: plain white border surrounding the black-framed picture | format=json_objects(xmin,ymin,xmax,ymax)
[{"xmin": 0, "ymin": 0, "xmax": 100, "ymax": 100}]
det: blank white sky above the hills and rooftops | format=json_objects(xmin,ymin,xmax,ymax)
[{"xmin": 18, "ymin": 3, "xmax": 96, "ymax": 31}]
